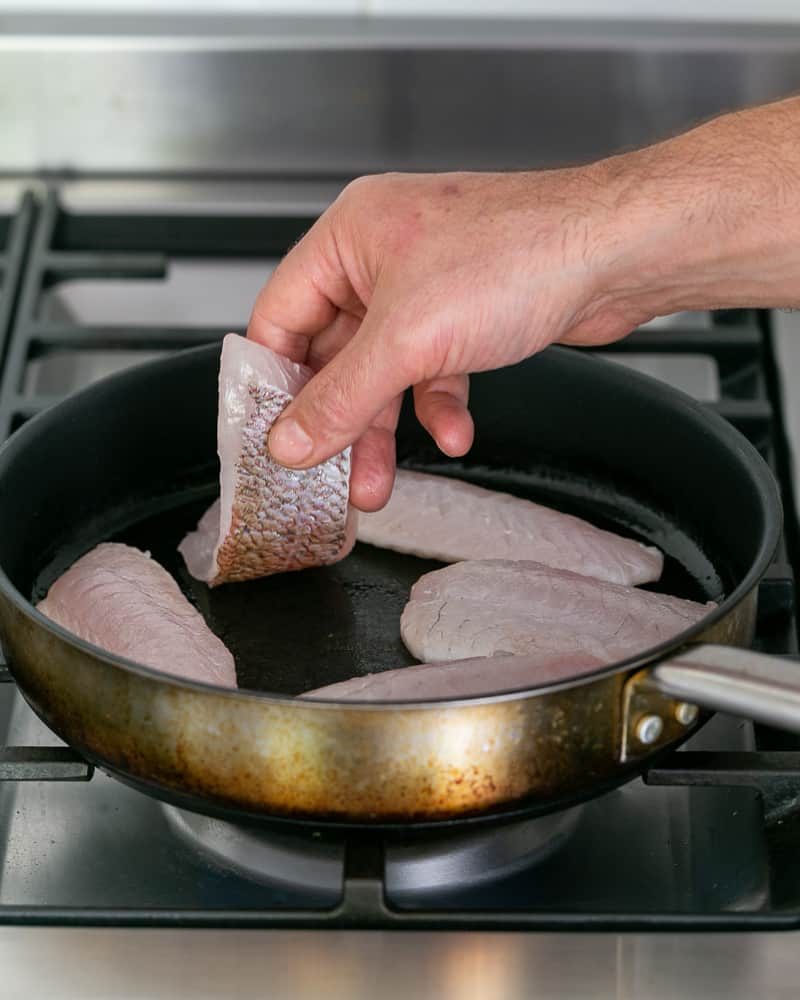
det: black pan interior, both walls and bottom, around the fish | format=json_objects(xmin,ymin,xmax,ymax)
[{"xmin": 0, "ymin": 347, "xmax": 768, "ymax": 695}]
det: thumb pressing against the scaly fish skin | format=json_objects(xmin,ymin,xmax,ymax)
[{"xmin": 268, "ymin": 313, "xmax": 414, "ymax": 469}]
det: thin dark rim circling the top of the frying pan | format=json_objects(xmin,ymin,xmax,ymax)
[{"xmin": 0, "ymin": 343, "xmax": 783, "ymax": 712}]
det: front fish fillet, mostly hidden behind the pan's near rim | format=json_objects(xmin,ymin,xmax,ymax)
[{"xmin": 301, "ymin": 655, "xmax": 603, "ymax": 701}]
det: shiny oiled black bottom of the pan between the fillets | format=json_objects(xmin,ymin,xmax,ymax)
[{"xmin": 67, "ymin": 466, "xmax": 730, "ymax": 695}]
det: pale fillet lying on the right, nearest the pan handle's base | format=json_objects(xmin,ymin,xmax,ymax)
[{"xmin": 400, "ymin": 559, "xmax": 716, "ymax": 668}]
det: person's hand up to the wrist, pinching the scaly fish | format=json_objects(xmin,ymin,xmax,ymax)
[{"xmin": 248, "ymin": 169, "xmax": 640, "ymax": 510}]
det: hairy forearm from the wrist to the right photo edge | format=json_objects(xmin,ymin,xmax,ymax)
[{"xmin": 590, "ymin": 98, "xmax": 800, "ymax": 315}]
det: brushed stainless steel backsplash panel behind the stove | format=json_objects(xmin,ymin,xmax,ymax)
[{"xmin": 0, "ymin": 15, "xmax": 800, "ymax": 176}]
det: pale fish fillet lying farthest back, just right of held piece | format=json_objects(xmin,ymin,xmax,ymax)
[{"xmin": 358, "ymin": 469, "xmax": 664, "ymax": 586}]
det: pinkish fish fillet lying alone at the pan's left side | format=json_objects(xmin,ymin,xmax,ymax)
[{"xmin": 37, "ymin": 542, "xmax": 236, "ymax": 687}]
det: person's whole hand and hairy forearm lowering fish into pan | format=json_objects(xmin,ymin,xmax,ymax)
[{"xmin": 248, "ymin": 100, "xmax": 800, "ymax": 511}]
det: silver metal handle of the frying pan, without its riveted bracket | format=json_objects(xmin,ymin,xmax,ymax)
[{"xmin": 650, "ymin": 644, "xmax": 800, "ymax": 732}]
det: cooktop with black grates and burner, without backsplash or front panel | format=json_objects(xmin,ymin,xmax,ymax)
[{"xmin": 0, "ymin": 186, "xmax": 800, "ymax": 933}]
